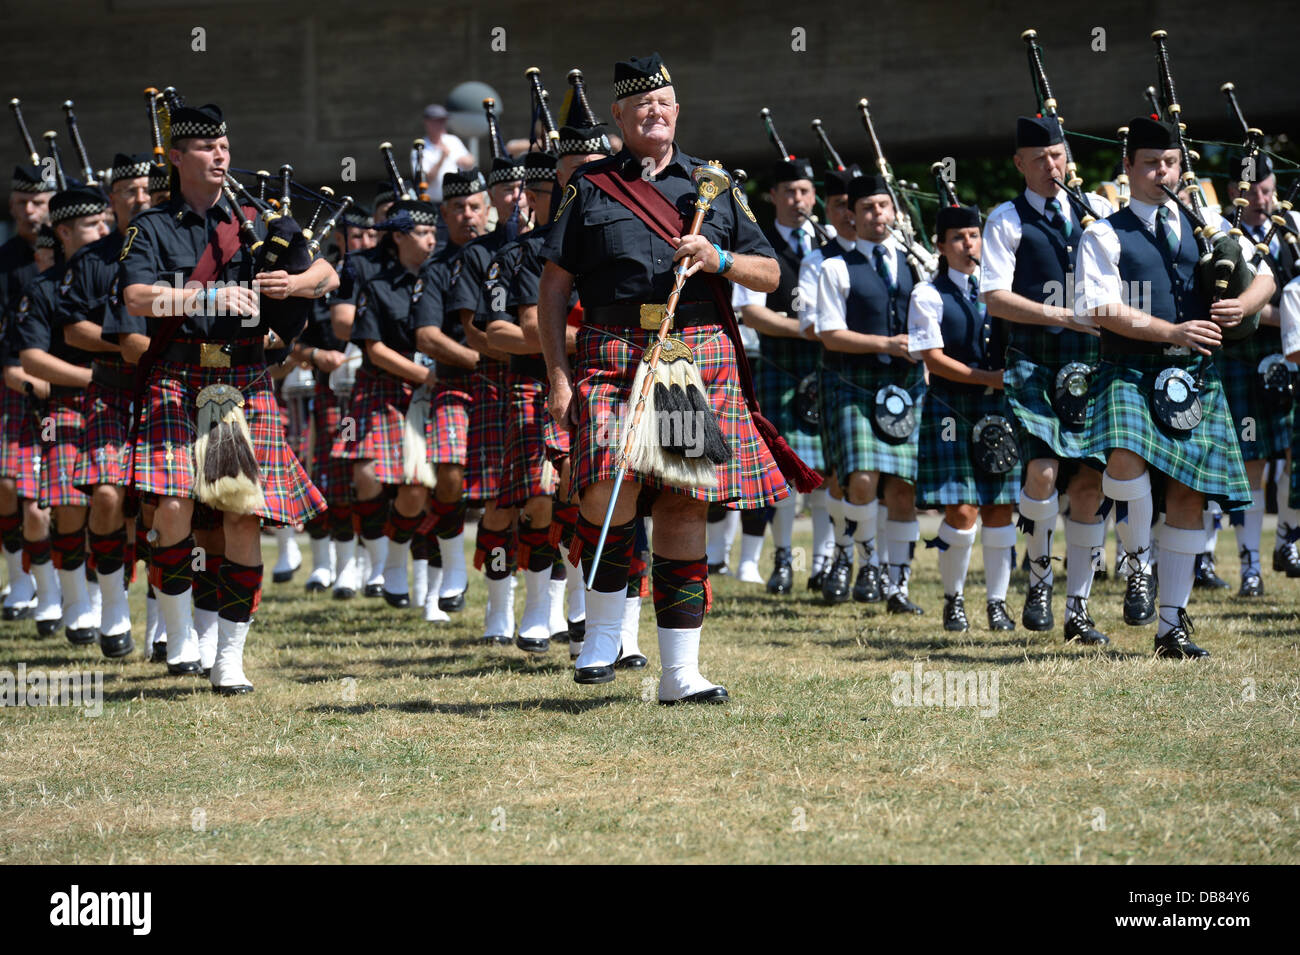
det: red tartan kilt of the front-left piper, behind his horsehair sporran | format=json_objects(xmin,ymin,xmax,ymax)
[{"xmin": 133, "ymin": 361, "xmax": 325, "ymax": 524}]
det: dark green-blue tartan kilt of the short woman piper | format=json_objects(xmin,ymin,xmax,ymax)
[{"xmin": 917, "ymin": 378, "xmax": 1021, "ymax": 508}]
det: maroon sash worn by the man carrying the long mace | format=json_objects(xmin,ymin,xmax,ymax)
[{"xmin": 584, "ymin": 169, "xmax": 822, "ymax": 494}]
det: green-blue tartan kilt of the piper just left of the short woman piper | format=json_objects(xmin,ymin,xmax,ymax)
[{"xmin": 822, "ymin": 355, "xmax": 926, "ymax": 485}]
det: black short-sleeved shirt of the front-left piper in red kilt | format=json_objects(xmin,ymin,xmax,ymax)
[{"xmin": 120, "ymin": 196, "xmax": 269, "ymax": 342}]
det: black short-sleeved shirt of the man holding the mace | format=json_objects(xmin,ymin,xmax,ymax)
[{"xmin": 542, "ymin": 146, "xmax": 775, "ymax": 308}]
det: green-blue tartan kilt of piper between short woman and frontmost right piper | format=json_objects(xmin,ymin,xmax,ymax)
[{"xmin": 1002, "ymin": 322, "xmax": 1106, "ymax": 468}]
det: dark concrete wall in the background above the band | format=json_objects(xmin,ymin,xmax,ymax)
[{"xmin": 0, "ymin": 0, "xmax": 1296, "ymax": 200}]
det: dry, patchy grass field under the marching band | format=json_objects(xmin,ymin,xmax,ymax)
[{"xmin": 0, "ymin": 520, "xmax": 1300, "ymax": 863}]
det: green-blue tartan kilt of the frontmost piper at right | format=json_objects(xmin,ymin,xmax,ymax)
[{"xmin": 1092, "ymin": 355, "xmax": 1251, "ymax": 511}]
